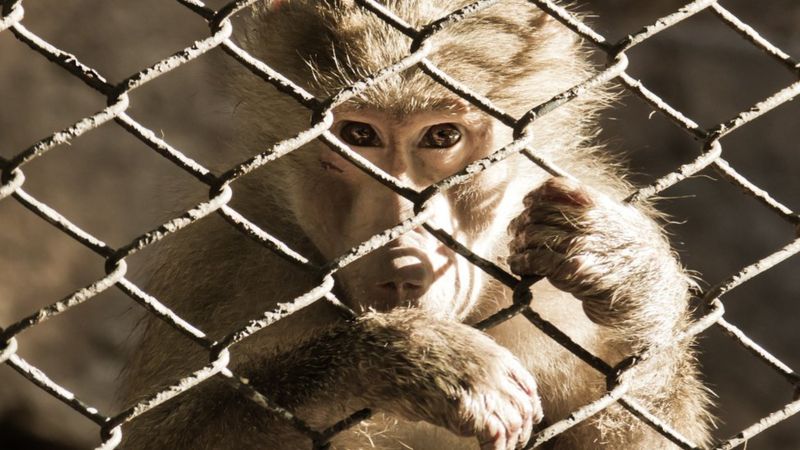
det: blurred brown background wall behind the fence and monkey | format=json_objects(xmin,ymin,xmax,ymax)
[{"xmin": 0, "ymin": 0, "xmax": 800, "ymax": 450}]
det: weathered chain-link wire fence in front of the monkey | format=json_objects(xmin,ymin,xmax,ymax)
[{"xmin": 0, "ymin": 0, "xmax": 800, "ymax": 449}]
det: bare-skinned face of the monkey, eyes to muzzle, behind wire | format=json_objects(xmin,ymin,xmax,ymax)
[{"xmin": 284, "ymin": 103, "xmax": 507, "ymax": 319}]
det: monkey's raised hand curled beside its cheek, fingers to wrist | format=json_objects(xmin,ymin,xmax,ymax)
[{"xmin": 508, "ymin": 177, "xmax": 688, "ymax": 326}]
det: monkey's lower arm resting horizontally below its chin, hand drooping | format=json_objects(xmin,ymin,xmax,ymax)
[{"xmin": 123, "ymin": 309, "xmax": 542, "ymax": 450}]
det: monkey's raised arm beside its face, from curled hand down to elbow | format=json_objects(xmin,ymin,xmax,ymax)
[{"xmin": 508, "ymin": 178, "xmax": 709, "ymax": 449}]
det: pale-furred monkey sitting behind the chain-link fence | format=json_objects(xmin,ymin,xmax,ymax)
[{"xmin": 120, "ymin": 0, "xmax": 713, "ymax": 450}]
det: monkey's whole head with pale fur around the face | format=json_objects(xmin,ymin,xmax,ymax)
[{"xmin": 228, "ymin": 1, "xmax": 606, "ymax": 320}]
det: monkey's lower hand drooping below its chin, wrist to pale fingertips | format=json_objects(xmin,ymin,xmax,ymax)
[{"xmin": 360, "ymin": 309, "xmax": 543, "ymax": 450}]
